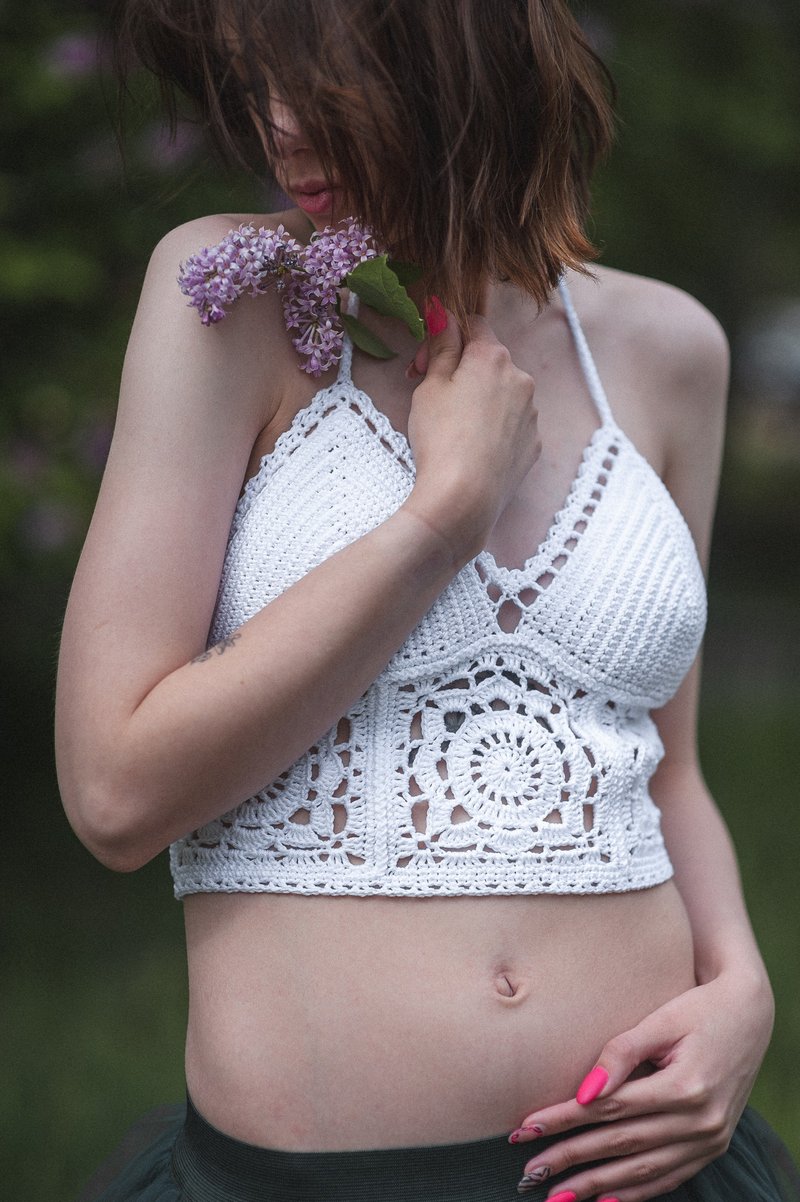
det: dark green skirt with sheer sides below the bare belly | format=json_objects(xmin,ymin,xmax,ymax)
[{"xmin": 78, "ymin": 1100, "xmax": 800, "ymax": 1202}]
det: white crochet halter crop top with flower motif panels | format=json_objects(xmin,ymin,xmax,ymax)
[{"xmin": 171, "ymin": 285, "xmax": 705, "ymax": 897}]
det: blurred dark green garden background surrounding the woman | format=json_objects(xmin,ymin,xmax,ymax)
[{"xmin": 0, "ymin": 0, "xmax": 800, "ymax": 1202}]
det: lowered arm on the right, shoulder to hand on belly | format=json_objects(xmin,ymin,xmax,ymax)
[{"xmin": 511, "ymin": 278, "xmax": 772, "ymax": 1202}]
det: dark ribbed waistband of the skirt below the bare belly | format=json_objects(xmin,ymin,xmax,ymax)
[{"xmin": 172, "ymin": 1097, "xmax": 553, "ymax": 1202}]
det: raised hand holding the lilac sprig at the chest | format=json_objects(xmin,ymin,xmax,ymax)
[{"xmin": 406, "ymin": 300, "xmax": 542, "ymax": 563}]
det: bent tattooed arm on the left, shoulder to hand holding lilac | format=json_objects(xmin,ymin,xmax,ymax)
[{"xmin": 56, "ymin": 219, "xmax": 538, "ymax": 870}]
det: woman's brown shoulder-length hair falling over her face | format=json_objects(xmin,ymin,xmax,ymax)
[{"xmin": 114, "ymin": 0, "xmax": 614, "ymax": 320}]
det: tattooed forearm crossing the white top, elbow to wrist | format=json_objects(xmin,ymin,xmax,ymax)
[{"xmin": 62, "ymin": 507, "xmax": 460, "ymax": 868}]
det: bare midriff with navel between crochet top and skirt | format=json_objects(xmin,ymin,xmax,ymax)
[{"xmin": 185, "ymin": 881, "xmax": 694, "ymax": 1152}]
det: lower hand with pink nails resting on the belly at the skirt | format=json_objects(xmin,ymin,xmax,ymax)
[{"xmin": 513, "ymin": 971, "xmax": 772, "ymax": 1202}]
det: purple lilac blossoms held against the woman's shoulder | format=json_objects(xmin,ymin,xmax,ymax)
[{"xmin": 178, "ymin": 218, "xmax": 378, "ymax": 376}]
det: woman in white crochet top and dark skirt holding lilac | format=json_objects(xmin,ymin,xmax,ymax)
[{"xmin": 56, "ymin": 0, "xmax": 798, "ymax": 1202}]
